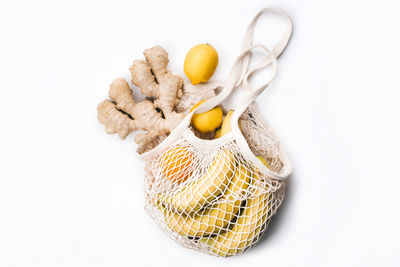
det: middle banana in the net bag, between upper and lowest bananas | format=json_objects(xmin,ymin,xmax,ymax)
[{"xmin": 165, "ymin": 165, "xmax": 251, "ymax": 237}]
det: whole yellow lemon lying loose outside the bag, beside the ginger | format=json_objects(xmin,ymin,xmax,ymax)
[{"xmin": 183, "ymin": 44, "xmax": 218, "ymax": 84}]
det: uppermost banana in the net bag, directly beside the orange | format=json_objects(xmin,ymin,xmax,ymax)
[{"xmin": 159, "ymin": 111, "xmax": 235, "ymax": 214}]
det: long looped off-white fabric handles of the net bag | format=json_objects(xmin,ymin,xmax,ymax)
[{"xmin": 193, "ymin": 7, "xmax": 293, "ymax": 115}]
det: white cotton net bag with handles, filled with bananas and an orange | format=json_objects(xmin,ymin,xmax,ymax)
[{"xmin": 140, "ymin": 8, "xmax": 292, "ymax": 256}]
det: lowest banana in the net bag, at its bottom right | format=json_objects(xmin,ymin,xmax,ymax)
[{"xmin": 200, "ymin": 173, "xmax": 271, "ymax": 257}]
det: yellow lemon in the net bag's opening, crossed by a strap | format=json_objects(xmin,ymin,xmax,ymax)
[{"xmin": 190, "ymin": 100, "xmax": 223, "ymax": 133}]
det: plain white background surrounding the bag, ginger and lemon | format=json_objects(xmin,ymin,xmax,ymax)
[{"xmin": 0, "ymin": 0, "xmax": 400, "ymax": 267}]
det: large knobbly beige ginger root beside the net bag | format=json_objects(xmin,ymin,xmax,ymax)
[{"xmin": 97, "ymin": 46, "xmax": 217, "ymax": 154}]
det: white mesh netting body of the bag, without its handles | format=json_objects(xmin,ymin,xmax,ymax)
[{"xmin": 145, "ymin": 109, "xmax": 289, "ymax": 256}]
